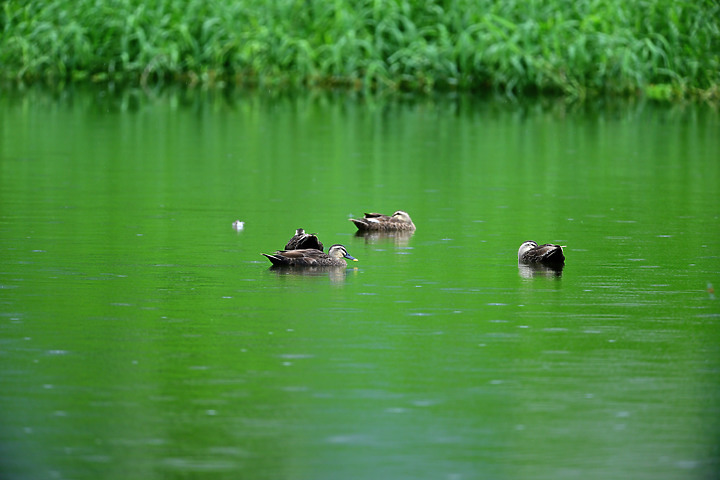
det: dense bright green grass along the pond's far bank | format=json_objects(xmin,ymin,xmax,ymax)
[{"xmin": 0, "ymin": 0, "xmax": 720, "ymax": 103}]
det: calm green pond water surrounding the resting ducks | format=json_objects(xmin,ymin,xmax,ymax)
[{"xmin": 0, "ymin": 89, "xmax": 720, "ymax": 480}]
